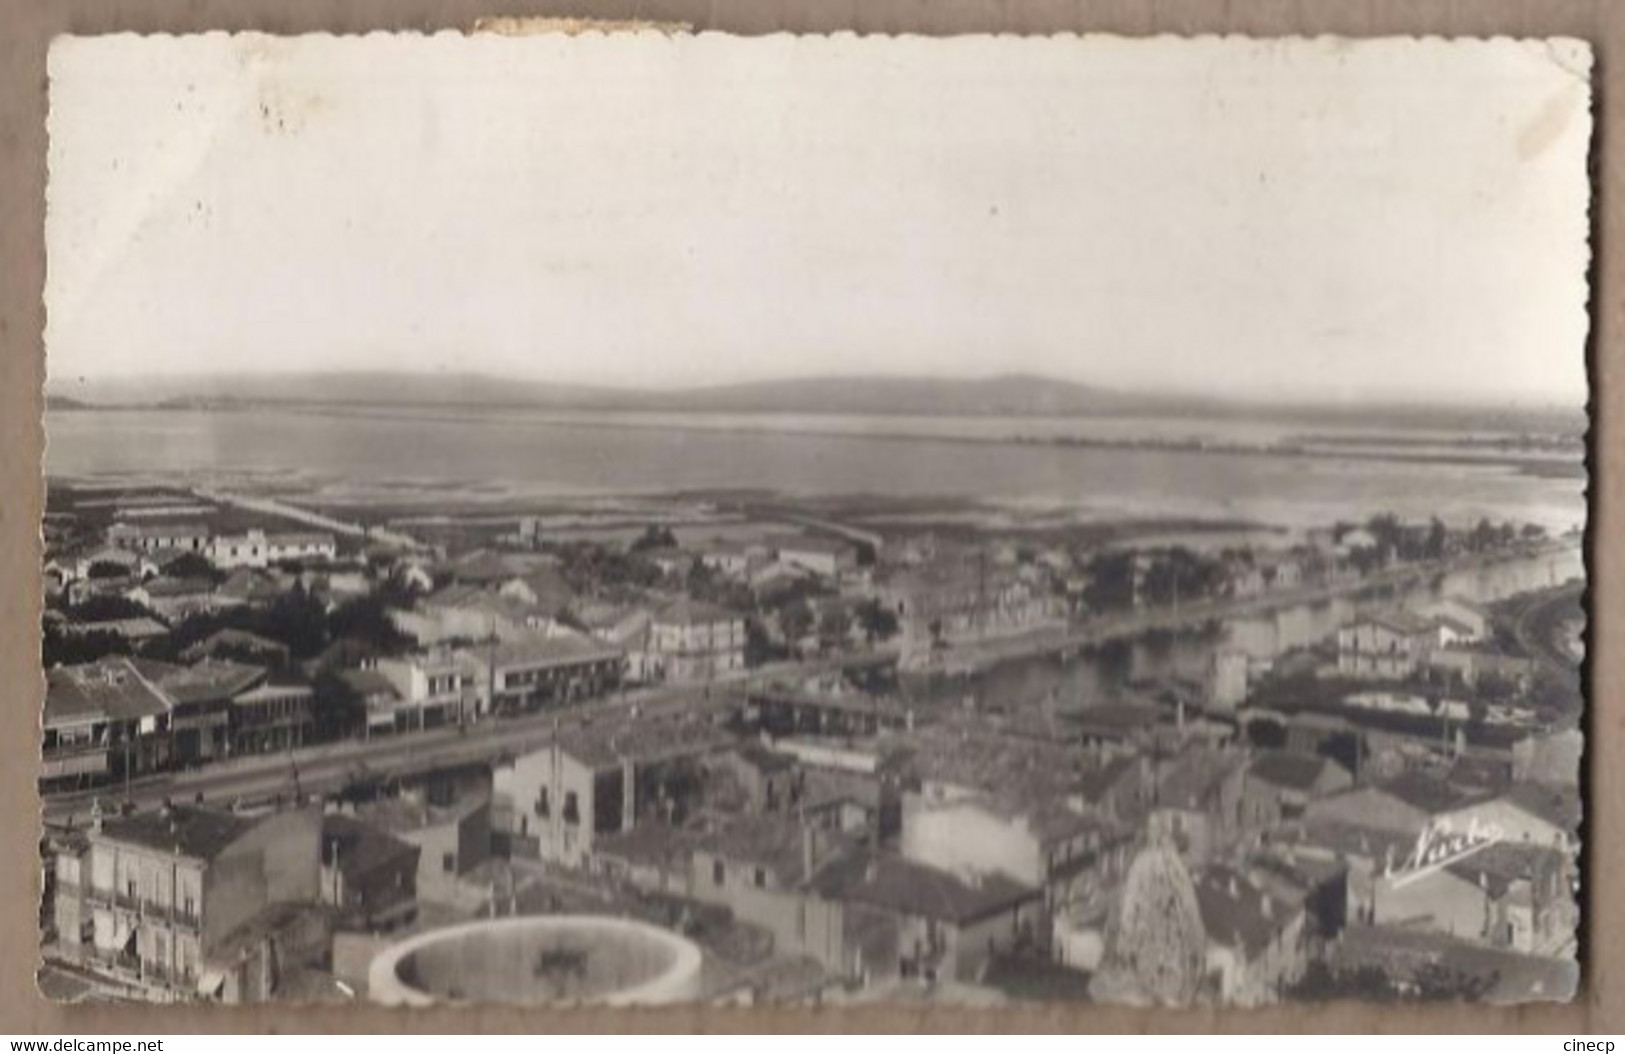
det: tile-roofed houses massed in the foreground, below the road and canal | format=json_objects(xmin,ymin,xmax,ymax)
[{"xmin": 38, "ymin": 649, "xmax": 1580, "ymax": 1004}]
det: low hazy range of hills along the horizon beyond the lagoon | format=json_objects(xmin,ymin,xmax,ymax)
[{"xmin": 47, "ymin": 372, "xmax": 1586, "ymax": 432}]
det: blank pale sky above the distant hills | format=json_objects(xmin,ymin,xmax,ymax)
[{"xmin": 47, "ymin": 36, "xmax": 1591, "ymax": 403}]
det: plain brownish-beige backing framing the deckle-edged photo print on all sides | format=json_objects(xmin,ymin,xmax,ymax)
[{"xmin": 0, "ymin": 0, "xmax": 1625, "ymax": 1043}]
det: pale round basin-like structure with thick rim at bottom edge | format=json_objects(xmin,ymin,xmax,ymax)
[{"xmin": 367, "ymin": 914, "xmax": 700, "ymax": 1007}]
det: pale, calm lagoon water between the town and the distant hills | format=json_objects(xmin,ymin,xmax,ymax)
[{"xmin": 46, "ymin": 402, "xmax": 1586, "ymax": 531}]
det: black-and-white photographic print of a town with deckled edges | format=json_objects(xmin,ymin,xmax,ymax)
[{"xmin": 29, "ymin": 31, "xmax": 1591, "ymax": 1007}]
